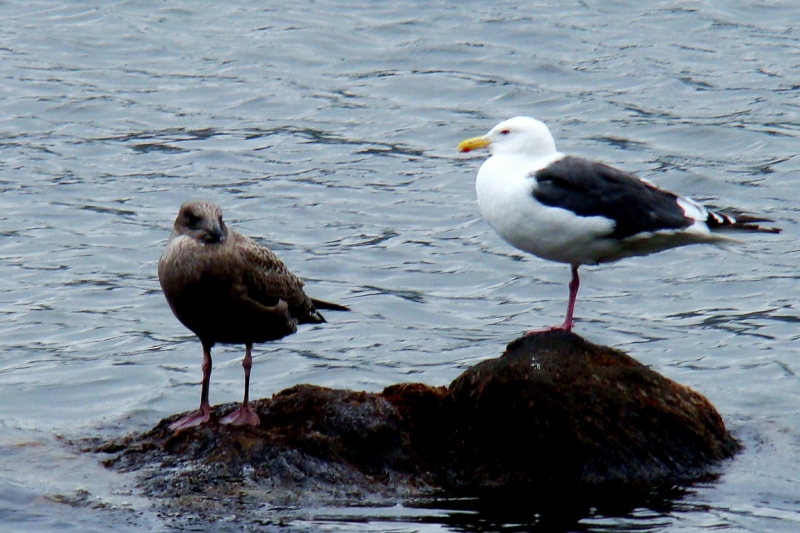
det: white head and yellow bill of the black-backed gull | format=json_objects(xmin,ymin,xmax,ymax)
[{"xmin": 458, "ymin": 117, "xmax": 556, "ymax": 159}]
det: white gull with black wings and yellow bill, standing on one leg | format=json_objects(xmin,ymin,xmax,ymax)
[{"xmin": 458, "ymin": 117, "xmax": 781, "ymax": 334}]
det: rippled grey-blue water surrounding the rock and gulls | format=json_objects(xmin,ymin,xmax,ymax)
[{"xmin": 0, "ymin": 0, "xmax": 800, "ymax": 532}]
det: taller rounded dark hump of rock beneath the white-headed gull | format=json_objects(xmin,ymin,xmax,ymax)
[{"xmin": 441, "ymin": 331, "xmax": 739, "ymax": 508}]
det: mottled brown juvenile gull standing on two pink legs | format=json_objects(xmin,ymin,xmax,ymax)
[{"xmin": 158, "ymin": 201, "xmax": 347, "ymax": 429}]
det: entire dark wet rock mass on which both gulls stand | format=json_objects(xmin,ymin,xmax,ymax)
[{"xmin": 94, "ymin": 332, "xmax": 739, "ymax": 513}]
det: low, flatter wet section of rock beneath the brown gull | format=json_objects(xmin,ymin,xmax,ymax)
[{"xmin": 94, "ymin": 385, "xmax": 444, "ymax": 514}]
